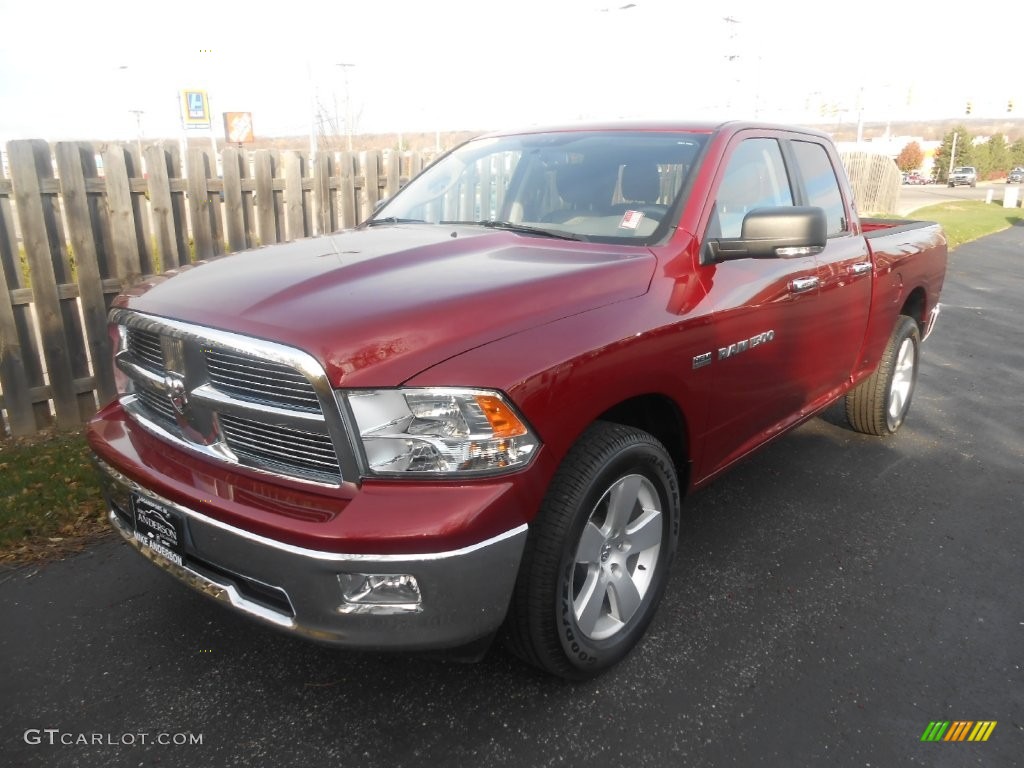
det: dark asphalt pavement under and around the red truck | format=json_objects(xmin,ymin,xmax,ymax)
[{"xmin": 0, "ymin": 226, "xmax": 1024, "ymax": 768}]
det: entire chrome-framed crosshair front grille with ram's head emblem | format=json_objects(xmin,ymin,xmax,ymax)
[{"xmin": 111, "ymin": 309, "xmax": 346, "ymax": 484}]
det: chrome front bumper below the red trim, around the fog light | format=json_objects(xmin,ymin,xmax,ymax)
[{"xmin": 93, "ymin": 457, "xmax": 526, "ymax": 650}]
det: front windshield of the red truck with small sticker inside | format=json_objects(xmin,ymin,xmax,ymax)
[{"xmin": 368, "ymin": 131, "xmax": 707, "ymax": 243}]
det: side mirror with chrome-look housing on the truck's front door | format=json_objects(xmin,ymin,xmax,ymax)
[{"xmin": 701, "ymin": 206, "xmax": 828, "ymax": 264}]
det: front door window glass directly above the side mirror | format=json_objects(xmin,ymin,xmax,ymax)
[{"xmin": 708, "ymin": 138, "xmax": 793, "ymax": 238}]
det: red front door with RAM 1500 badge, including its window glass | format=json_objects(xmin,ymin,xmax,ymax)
[{"xmin": 697, "ymin": 134, "xmax": 820, "ymax": 477}]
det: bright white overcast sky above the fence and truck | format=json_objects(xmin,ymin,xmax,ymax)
[{"xmin": 0, "ymin": 0, "xmax": 1024, "ymax": 142}]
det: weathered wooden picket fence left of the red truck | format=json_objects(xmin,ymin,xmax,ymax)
[{"xmin": 0, "ymin": 140, "xmax": 432, "ymax": 439}]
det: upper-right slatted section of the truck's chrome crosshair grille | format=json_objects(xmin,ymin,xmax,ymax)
[{"xmin": 206, "ymin": 349, "xmax": 319, "ymax": 412}]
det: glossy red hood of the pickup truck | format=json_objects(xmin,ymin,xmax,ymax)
[{"xmin": 119, "ymin": 225, "xmax": 655, "ymax": 387}]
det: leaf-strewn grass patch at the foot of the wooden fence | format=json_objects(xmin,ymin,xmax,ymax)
[{"xmin": 0, "ymin": 432, "xmax": 109, "ymax": 562}]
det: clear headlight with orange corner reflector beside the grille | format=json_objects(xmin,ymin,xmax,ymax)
[{"xmin": 343, "ymin": 389, "xmax": 540, "ymax": 475}]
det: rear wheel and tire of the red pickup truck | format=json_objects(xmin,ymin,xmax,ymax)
[{"xmin": 846, "ymin": 314, "xmax": 921, "ymax": 437}]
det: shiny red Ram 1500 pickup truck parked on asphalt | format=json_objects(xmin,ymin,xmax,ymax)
[{"xmin": 88, "ymin": 122, "xmax": 946, "ymax": 679}]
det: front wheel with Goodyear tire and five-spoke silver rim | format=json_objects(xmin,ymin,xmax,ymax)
[{"xmin": 505, "ymin": 422, "xmax": 680, "ymax": 680}]
